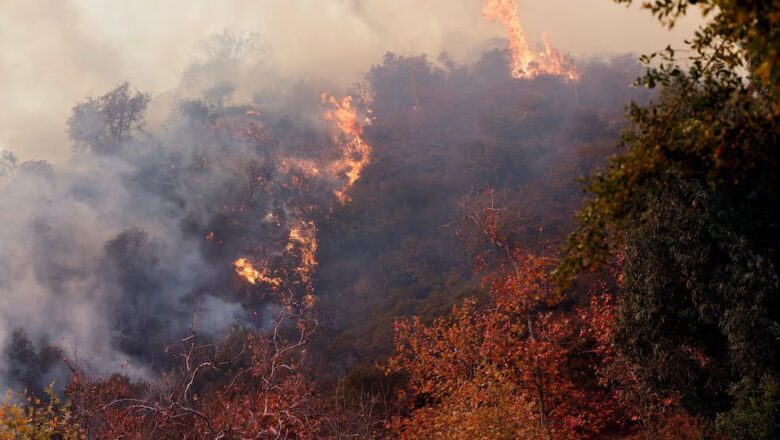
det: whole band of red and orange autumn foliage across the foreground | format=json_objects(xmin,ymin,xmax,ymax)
[{"xmin": 0, "ymin": 197, "xmax": 704, "ymax": 439}]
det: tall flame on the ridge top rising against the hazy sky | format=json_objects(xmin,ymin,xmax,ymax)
[{"xmin": 482, "ymin": 0, "xmax": 580, "ymax": 81}]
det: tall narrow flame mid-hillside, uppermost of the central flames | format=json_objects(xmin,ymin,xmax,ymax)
[{"xmin": 322, "ymin": 93, "xmax": 372, "ymax": 203}]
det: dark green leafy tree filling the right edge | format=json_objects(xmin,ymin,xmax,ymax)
[{"xmin": 556, "ymin": 0, "xmax": 780, "ymax": 426}]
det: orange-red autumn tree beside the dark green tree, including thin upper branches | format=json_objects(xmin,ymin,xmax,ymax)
[{"xmin": 388, "ymin": 198, "xmax": 644, "ymax": 439}]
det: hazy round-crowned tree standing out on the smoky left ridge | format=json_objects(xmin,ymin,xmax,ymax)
[{"xmin": 68, "ymin": 82, "xmax": 151, "ymax": 154}]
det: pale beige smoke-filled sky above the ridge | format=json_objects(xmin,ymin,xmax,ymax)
[{"xmin": 0, "ymin": 0, "xmax": 698, "ymax": 162}]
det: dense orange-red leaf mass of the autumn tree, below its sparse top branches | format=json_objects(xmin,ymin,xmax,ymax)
[{"xmin": 389, "ymin": 272, "xmax": 635, "ymax": 439}]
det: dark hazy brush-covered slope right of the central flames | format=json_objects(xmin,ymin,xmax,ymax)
[{"xmin": 315, "ymin": 51, "xmax": 651, "ymax": 376}]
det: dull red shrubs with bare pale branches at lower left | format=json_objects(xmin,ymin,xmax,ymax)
[{"xmin": 66, "ymin": 326, "xmax": 317, "ymax": 439}]
